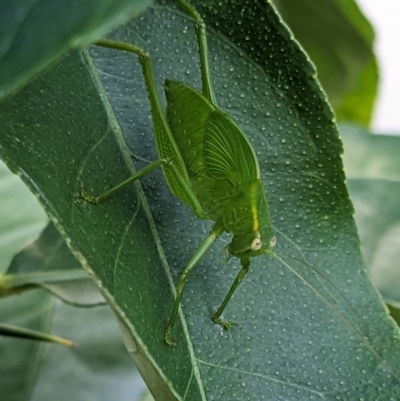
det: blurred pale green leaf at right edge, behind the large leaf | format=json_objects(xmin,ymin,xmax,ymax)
[{"xmin": 341, "ymin": 126, "xmax": 400, "ymax": 308}]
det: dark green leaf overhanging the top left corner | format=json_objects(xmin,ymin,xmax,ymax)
[{"xmin": 0, "ymin": 0, "xmax": 151, "ymax": 99}]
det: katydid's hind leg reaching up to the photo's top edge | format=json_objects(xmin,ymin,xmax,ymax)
[{"xmin": 176, "ymin": 0, "xmax": 218, "ymax": 107}]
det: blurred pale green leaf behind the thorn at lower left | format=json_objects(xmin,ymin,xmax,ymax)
[{"xmin": 0, "ymin": 290, "xmax": 144, "ymax": 401}]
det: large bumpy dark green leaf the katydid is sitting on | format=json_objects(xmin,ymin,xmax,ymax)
[{"xmin": 1, "ymin": 1, "xmax": 400, "ymax": 401}]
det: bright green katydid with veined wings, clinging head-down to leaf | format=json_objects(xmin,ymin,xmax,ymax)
[{"xmin": 82, "ymin": 0, "xmax": 276, "ymax": 345}]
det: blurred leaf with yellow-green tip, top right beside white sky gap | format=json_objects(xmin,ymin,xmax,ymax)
[{"xmin": 274, "ymin": 0, "xmax": 379, "ymax": 125}]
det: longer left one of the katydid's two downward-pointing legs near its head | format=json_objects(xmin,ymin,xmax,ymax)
[{"xmin": 164, "ymin": 223, "xmax": 225, "ymax": 345}]
